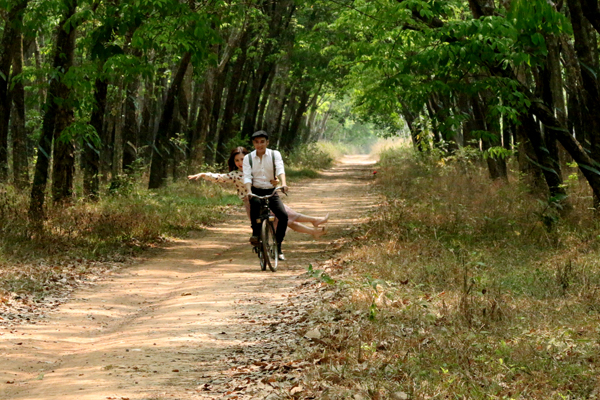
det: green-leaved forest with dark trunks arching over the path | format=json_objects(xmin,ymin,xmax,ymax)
[{"xmin": 0, "ymin": 0, "xmax": 600, "ymax": 216}]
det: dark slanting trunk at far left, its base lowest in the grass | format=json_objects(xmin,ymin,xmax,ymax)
[{"xmin": 29, "ymin": 0, "xmax": 77, "ymax": 219}]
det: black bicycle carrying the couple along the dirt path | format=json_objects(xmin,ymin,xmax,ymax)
[{"xmin": 249, "ymin": 186, "xmax": 283, "ymax": 272}]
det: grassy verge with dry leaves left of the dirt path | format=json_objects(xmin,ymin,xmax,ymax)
[{"xmin": 0, "ymin": 178, "xmax": 239, "ymax": 296}]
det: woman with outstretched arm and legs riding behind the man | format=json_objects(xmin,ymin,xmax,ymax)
[{"xmin": 188, "ymin": 147, "xmax": 329, "ymax": 239}]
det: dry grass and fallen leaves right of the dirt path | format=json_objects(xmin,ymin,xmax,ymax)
[{"xmin": 298, "ymin": 148, "xmax": 600, "ymax": 399}]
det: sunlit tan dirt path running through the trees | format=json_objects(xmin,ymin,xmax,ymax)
[{"xmin": 0, "ymin": 156, "xmax": 374, "ymax": 400}]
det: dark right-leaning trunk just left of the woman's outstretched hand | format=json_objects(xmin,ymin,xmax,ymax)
[{"xmin": 148, "ymin": 52, "xmax": 191, "ymax": 189}]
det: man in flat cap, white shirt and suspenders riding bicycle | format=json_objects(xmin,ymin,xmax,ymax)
[{"xmin": 243, "ymin": 131, "xmax": 288, "ymax": 260}]
